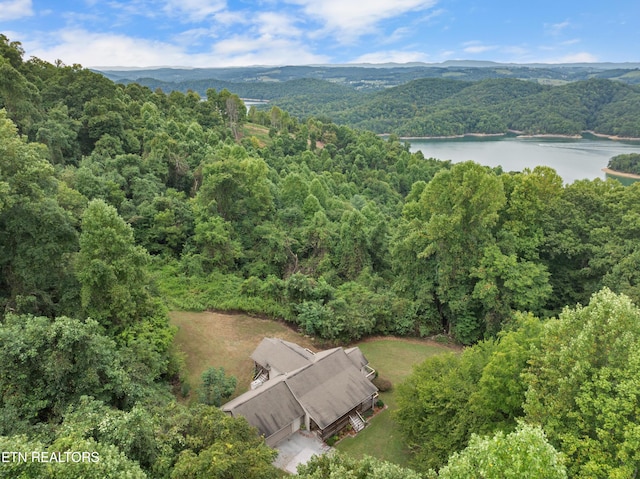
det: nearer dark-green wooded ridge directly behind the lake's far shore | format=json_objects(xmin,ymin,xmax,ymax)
[{"xmin": 274, "ymin": 79, "xmax": 640, "ymax": 138}]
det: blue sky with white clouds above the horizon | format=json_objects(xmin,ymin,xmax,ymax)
[{"xmin": 0, "ymin": 0, "xmax": 640, "ymax": 67}]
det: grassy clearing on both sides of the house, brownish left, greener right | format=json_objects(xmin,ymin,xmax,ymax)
[{"xmin": 170, "ymin": 311, "xmax": 452, "ymax": 465}]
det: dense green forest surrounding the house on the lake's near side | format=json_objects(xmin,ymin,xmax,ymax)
[{"xmin": 0, "ymin": 31, "xmax": 640, "ymax": 478}]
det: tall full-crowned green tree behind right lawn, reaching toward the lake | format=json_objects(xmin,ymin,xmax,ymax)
[{"xmin": 410, "ymin": 162, "xmax": 506, "ymax": 344}]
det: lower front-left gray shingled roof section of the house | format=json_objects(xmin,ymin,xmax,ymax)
[{"xmin": 222, "ymin": 376, "xmax": 304, "ymax": 437}]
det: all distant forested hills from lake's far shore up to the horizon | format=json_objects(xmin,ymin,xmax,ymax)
[{"xmin": 107, "ymin": 67, "xmax": 640, "ymax": 138}]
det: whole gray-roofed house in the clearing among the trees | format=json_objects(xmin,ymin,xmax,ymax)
[{"xmin": 222, "ymin": 338, "xmax": 378, "ymax": 446}]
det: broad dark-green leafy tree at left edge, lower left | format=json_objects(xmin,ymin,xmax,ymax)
[{"xmin": 0, "ymin": 315, "xmax": 133, "ymax": 434}]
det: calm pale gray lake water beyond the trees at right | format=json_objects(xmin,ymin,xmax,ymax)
[{"xmin": 409, "ymin": 137, "xmax": 640, "ymax": 188}]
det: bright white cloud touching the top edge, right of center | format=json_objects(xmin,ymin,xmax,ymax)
[{"xmin": 285, "ymin": 0, "xmax": 437, "ymax": 42}]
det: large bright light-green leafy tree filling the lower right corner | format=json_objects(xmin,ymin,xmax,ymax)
[{"xmin": 524, "ymin": 289, "xmax": 640, "ymax": 478}]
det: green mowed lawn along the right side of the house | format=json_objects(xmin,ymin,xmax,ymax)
[{"xmin": 336, "ymin": 338, "xmax": 455, "ymax": 466}]
